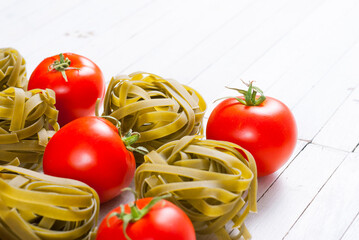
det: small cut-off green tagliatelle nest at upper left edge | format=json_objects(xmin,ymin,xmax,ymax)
[{"xmin": 0, "ymin": 48, "xmax": 27, "ymax": 91}]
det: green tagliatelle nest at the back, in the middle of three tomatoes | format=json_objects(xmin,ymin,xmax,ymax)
[{"xmin": 103, "ymin": 72, "xmax": 206, "ymax": 157}]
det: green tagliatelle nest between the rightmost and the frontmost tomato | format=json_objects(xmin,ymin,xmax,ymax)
[{"xmin": 135, "ymin": 136, "xmax": 257, "ymax": 240}]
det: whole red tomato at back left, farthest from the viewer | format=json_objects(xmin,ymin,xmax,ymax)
[{"xmin": 28, "ymin": 53, "xmax": 105, "ymax": 126}]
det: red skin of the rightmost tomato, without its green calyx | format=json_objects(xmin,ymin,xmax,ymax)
[{"xmin": 206, "ymin": 97, "xmax": 297, "ymax": 177}]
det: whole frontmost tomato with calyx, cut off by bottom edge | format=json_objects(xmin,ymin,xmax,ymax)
[{"xmin": 96, "ymin": 189, "xmax": 196, "ymax": 240}]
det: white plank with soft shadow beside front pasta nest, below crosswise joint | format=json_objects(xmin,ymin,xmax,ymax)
[{"xmin": 246, "ymin": 144, "xmax": 347, "ymax": 240}]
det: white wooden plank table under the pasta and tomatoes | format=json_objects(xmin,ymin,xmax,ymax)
[{"xmin": 0, "ymin": 0, "xmax": 359, "ymax": 240}]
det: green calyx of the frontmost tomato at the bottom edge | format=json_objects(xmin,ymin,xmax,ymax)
[{"xmin": 106, "ymin": 188, "xmax": 171, "ymax": 240}]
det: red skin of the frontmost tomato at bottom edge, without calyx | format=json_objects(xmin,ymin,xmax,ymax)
[{"xmin": 96, "ymin": 198, "xmax": 196, "ymax": 240}]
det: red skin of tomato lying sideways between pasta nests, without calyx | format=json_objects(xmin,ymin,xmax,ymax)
[{"xmin": 43, "ymin": 116, "xmax": 136, "ymax": 203}]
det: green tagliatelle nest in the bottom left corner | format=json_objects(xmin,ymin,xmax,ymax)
[{"xmin": 0, "ymin": 159, "xmax": 99, "ymax": 240}]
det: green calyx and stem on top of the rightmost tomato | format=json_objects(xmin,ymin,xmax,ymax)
[{"xmin": 222, "ymin": 80, "xmax": 266, "ymax": 106}]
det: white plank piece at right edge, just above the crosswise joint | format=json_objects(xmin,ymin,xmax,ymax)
[{"xmin": 313, "ymin": 87, "xmax": 359, "ymax": 151}]
